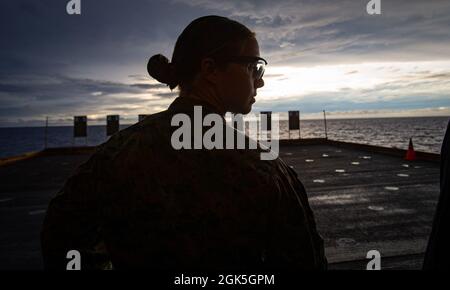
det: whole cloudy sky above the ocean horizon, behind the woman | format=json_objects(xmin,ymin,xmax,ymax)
[{"xmin": 0, "ymin": 0, "xmax": 450, "ymax": 127}]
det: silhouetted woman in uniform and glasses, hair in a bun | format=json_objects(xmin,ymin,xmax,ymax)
[{"xmin": 42, "ymin": 16, "xmax": 326, "ymax": 270}]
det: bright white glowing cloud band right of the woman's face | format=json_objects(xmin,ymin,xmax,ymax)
[{"xmin": 250, "ymin": 62, "xmax": 450, "ymax": 113}]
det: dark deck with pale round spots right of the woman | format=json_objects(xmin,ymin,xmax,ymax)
[{"xmin": 281, "ymin": 145, "xmax": 439, "ymax": 269}]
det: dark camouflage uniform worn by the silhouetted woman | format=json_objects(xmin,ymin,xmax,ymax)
[{"xmin": 41, "ymin": 97, "xmax": 327, "ymax": 270}]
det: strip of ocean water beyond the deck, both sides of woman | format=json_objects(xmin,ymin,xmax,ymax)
[{"xmin": 0, "ymin": 117, "xmax": 449, "ymax": 158}]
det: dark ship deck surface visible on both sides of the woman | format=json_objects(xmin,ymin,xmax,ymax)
[{"xmin": 0, "ymin": 145, "xmax": 439, "ymax": 270}]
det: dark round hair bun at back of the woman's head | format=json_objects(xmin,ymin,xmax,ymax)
[{"xmin": 147, "ymin": 54, "xmax": 177, "ymax": 89}]
